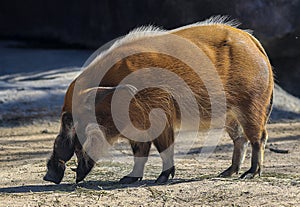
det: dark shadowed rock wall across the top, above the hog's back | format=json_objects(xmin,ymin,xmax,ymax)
[{"xmin": 0, "ymin": 0, "xmax": 300, "ymax": 97}]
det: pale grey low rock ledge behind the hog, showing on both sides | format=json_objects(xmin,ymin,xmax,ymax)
[{"xmin": 0, "ymin": 68, "xmax": 300, "ymax": 123}]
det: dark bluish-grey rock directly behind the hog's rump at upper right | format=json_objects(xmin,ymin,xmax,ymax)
[{"xmin": 235, "ymin": 0, "xmax": 300, "ymax": 97}]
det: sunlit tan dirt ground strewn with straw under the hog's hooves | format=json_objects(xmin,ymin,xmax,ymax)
[{"xmin": 0, "ymin": 122, "xmax": 300, "ymax": 206}]
